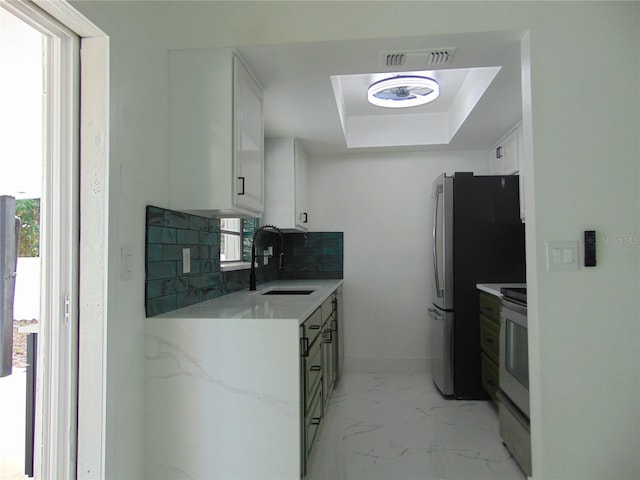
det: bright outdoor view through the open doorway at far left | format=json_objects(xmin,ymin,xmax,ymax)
[{"xmin": 0, "ymin": 8, "xmax": 45, "ymax": 479}]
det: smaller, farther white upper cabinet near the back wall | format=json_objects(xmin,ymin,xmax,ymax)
[{"xmin": 262, "ymin": 138, "xmax": 310, "ymax": 232}]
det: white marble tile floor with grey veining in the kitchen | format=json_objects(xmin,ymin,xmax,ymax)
[{"xmin": 306, "ymin": 374, "xmax": 526, "ymax": 480}]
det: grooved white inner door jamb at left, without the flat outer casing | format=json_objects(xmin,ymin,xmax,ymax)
[{"xmin": 2, "ymin": 2, "xmax": 80, "ymax": 478}]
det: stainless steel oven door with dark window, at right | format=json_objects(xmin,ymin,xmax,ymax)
[{"xmin": 500, "ymin": 298, "xmax": 529, "ymax": 418}]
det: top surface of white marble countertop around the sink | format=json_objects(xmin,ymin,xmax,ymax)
[{"xmin": 152, "ymin": 280, "xmax": 343, "ymax": 322}]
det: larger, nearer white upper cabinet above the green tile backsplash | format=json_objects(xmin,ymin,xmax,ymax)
[{"xmin": 169, "ymin": 48, "xmax": 264, "ymax": 217}]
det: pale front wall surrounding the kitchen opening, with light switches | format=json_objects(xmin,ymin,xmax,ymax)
[{"xmin": 67, "ymin": 2, "xmax": 640, "ymax": 479}]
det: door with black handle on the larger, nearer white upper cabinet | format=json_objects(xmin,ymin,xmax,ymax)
[{"xmin": 233, "ymin": 57, "xmax": 264, "ymax": 213}]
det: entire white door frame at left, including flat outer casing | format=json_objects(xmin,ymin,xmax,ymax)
[{"xmin": 0, "ymin": 0, "xmax": 109, "ymax": 479}]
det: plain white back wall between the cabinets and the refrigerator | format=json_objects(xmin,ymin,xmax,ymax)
[{"xmin": 310, "ymin": 151, "xmax": 488, "ymax": 372}]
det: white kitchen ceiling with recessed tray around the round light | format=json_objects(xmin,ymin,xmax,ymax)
[{"xmin": 237, "ymin": 32, "xmax": 522, "ymax": 155}]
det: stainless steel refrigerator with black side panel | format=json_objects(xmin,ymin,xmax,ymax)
[{"xmin": 428, "ymin": 172, "xmax": 525, "ymax": 399}]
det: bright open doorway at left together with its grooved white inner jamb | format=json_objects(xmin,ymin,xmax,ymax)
[{"xmin": 0, "ymin": 2, "xmax": 79, "ymax": 478}]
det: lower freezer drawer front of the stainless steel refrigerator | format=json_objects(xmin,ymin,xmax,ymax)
[{"xmin": 429, "ymin": 308, "xmax": 454, "ymax": 395}]
